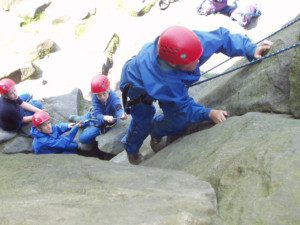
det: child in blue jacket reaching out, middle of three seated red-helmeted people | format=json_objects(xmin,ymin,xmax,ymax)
[{"xmin": 31, "ymin": 111, "xmax": 81, "ymax": 154}]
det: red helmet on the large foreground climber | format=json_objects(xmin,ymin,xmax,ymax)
[{"xmin": 158, "ymin": 26, "xmax": 203, "ymax": 65}]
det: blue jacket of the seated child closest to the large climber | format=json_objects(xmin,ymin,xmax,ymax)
[{"xmin": 92, "ymin": 91, "xmax": 124, "ymax": 126}]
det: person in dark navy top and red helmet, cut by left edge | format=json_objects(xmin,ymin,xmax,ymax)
[{"xmin": 0, "ymin": 78, "xmax": 43, "ymax": 131}]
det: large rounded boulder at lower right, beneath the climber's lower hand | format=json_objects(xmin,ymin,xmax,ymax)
[{"xmin": 143, "ymin": 113, "xmax": 300, "ymax": 225}]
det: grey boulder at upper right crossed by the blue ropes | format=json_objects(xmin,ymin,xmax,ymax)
[{"xmin": 190, "ymin": 16, "xmax": 300, "ymax": 116}]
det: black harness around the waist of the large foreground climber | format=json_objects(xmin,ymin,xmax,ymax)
[{"xmin": 122, "ymin": 83, "xmax": 153, "ymax": 114}]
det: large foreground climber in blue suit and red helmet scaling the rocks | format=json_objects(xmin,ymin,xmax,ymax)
[{"xmin": 120, "ymin": 26, "xmax": 272, "ymax": 164}]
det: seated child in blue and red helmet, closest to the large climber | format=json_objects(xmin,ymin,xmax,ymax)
[{"xmin": 69, "ymin": 75, "xmax": 127, "ymax": 144}]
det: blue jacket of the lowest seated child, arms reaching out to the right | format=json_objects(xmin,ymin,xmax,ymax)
[{"xmin": 31, "ymin": 123, "xmax": 79, "ymax": 154}]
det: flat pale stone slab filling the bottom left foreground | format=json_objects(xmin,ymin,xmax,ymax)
[{"xmin": 0, "ymin": 155, "xmax": 216, "ymax": 225}]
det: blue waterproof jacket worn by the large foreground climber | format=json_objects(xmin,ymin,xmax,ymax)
[{"xmin": 120, "ymin": 28, "xmax": 256, "ymax": 120}]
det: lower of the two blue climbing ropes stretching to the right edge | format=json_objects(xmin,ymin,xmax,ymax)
[{"xmin": 189, "ymin": 42, "xmax": 300, "ymax": 87}]
